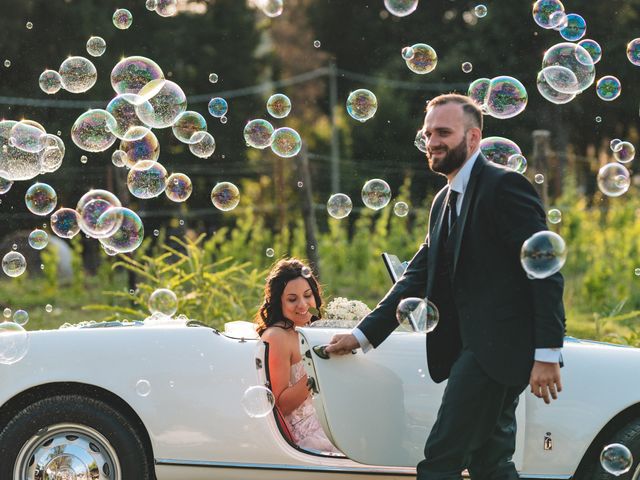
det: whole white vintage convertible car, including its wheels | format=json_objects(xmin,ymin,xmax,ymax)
[{"xmin": 0, "ymin": 256, "xmax": 640, "ymax": 480}]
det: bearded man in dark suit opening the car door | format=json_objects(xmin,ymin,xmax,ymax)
[{"xmin": 326, "ymin": 94, "xmax": 565, "ymax": 480}]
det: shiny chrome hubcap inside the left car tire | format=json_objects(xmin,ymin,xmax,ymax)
[{"xmin": 13, "ymin": 423, "xmax": 121, "ymax": 480}]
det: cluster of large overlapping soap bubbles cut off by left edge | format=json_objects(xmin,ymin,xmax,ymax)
[{"xmin": 0, "ymin": 120, "xmax": 66, "ymax": 180}]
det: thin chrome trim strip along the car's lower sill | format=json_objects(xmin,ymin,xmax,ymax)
[{"xmin": 155, "ymin": 458, "xmax": 416, "ymax": 477}]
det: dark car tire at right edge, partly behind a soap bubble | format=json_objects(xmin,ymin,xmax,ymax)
[{"xmin": 574, "ymin": 418, "xmax": 640, "ymax": 480}]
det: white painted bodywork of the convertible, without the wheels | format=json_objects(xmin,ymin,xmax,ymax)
[{"xmin": 0, "ymin": 321, "xmax": 640, "ymax": 480}]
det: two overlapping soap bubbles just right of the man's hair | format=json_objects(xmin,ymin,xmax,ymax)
[{"xmin": 467, "ymin": 75, "xmax": 529, "ymax": 119}]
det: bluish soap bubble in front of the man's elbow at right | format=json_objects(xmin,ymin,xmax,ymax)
[{"xmin": 520, "ymin": 230, "xmax": 567, "ymax": 279}]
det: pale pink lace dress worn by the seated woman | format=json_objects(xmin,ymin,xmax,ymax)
[{"xmin": 285, "ymin": 360, "xmax": 341, "ymax": 454}]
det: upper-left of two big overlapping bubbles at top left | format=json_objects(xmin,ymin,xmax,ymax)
[{"xmin": 111, "ymin": 56, "xmax": 164, "ymax": 98}]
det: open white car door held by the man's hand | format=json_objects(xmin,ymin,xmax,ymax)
[{"xmin": 299, "ymin": 327, "xmax": 525, "ymax": 468}]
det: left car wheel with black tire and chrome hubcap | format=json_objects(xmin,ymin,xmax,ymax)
[{"xmin": 0, "ymin": 395, "xmax": 154, "ymax": 480}]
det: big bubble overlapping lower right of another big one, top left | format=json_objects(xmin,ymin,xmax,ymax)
[{"xmin": 136, "ymin": 80, "xmax": 187, "ymax": 128}]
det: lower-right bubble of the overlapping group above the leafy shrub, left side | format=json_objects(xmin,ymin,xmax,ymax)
[{"xmin": 96, "ymin": 207, "xmax": 144, "ymax": 253}]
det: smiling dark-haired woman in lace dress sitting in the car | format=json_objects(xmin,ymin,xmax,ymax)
[{"xmin": 256, "ymin": 258, "xmax": 340, "ymax": 454}]
